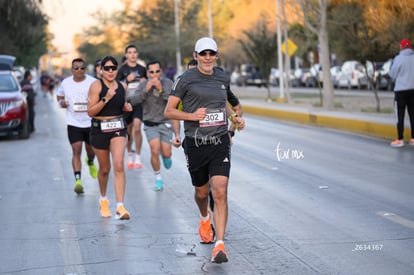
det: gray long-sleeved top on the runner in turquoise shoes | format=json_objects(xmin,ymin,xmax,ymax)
[{"xmin": 127, "ymin": 77, "xmax": 173, "ymax": 123}]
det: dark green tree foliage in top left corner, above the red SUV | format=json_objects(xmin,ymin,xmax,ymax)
[{"xmin": 0, "ymin": 0, "xmax": 50, "ymax": 67}]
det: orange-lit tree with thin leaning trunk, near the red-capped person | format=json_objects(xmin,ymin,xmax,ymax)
[{"xmin": 330, "ymin": 0, "xmax": 414, "ymax": 112}]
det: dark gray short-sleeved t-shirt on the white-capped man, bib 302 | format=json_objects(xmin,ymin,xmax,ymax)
[{"xmin": 171, "ymin": 68, "xmax": 230, "ymax": 139}]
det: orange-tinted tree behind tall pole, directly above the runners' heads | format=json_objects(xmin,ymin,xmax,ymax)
[{"xmin": 124, "ymin": 0, "xmax": 205, "ymax": 66}]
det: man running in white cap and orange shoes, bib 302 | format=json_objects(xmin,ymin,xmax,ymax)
[{"xmin": 165, "ymin": 37, "xmax": 244, "ymax": 263}]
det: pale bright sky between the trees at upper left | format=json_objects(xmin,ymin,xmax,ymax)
[{"xmin": 42, "ymin": 0, "xmax": 123, "ymax": 53}]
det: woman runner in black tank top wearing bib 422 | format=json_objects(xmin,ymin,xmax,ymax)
[{"xmin": 88, "ymin": 56, "xmax": 132, "ymax": 220}]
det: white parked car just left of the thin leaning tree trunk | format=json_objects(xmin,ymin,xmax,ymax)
[{"xmin": 336, "ymin": 60, "xmax": 373, "ymax": 89}]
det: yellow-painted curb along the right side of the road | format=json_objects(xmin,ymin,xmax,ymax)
[{"xmin": 243, "ymin": 104, "xmax": 410, "ymax": 141}]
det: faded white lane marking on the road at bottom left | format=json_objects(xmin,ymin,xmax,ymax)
[{"xmin": 59, "ymin": 221, "xmax": 86, "ymax": 274}]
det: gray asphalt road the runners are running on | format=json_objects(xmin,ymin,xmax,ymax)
[{"xmin": 0, "ymin": 94, "xmax": 414, "ymax": 275}]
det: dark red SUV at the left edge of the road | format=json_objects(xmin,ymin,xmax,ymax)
[{"xmin": 0, "ymin": 55, "xmax": 30, "ymax": 139}]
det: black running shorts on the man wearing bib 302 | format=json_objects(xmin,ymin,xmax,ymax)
[{"xmin": 183, "ymin": 134, "xmax": 231, "ymax": 186}]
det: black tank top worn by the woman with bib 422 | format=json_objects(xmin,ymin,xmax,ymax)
[{"xmin": 96, "ymin": 79, "xmax": 125, "ymax": 116}]
